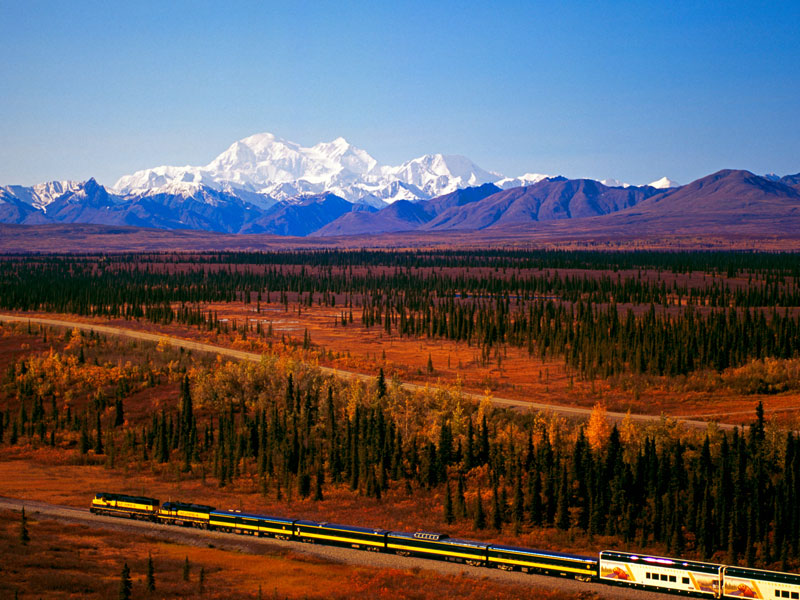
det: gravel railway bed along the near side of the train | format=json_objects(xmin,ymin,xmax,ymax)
[{"xmin": 0, "ymin": 496, "xmax": 674, "ymax": 600}]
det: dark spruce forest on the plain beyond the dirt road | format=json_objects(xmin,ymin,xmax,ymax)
[{"xmin": 0, "ymin": 252, "xmax": 800, "ymax": 378}]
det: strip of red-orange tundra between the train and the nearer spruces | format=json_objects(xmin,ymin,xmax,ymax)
[{"xmin": 0, "ymin": 454, "xmax": 655, "ymax": 555}]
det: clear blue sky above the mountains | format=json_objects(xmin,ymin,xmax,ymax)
[{"xmin": 0, "ymin": 0, "xmax": 800, "ymax": 185}]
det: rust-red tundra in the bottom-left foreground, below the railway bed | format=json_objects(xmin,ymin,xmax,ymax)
[{"xmin": 0, "ymin": 511, "xmax": 574, "ymax": 600}]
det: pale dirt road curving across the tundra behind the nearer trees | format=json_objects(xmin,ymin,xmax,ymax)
[{"xmin": 0, "ymin": 314, "xmax": 734, "ymax": 429}]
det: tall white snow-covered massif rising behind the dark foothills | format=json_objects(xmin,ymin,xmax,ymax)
[{"xmin": 114, "ymin": 133, "xmax": 501, "ymax": 207}]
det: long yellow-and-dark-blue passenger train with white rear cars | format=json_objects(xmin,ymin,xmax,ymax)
[{"xmin": 89, "ymin": 492, "xmax": 800, "ymax": 600}]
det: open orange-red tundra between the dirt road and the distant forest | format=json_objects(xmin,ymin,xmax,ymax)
[{"xmin": 6, "ymin": 303, "xmax": 800, "ymax": 428}]
